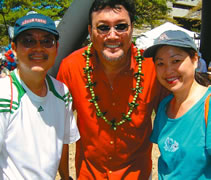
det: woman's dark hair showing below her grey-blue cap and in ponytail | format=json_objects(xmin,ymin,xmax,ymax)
[{"xmin": 153, "ymin": 45, "xmax": 211, "ymax": 86}]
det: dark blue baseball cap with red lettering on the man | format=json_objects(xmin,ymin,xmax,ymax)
[{"xmin": 13, "ymin": 13, "xmax": 59, "ymax": 41}]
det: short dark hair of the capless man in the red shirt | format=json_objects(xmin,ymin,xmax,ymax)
[{"xmin": 89, "ymin": 0, "xmax": 136, "ymax": 25}]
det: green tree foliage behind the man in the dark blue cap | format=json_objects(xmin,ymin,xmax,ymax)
[{"xmin": 0, "ymin": 0, "xmax": 72, "ymax": 45}]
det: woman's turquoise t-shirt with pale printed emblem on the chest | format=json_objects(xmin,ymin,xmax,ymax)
[{"xmin": 151, "ymin": 87, "xmax": 211, "ymax": 180}]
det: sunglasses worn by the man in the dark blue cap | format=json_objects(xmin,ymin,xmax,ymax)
[{"xmin": 20, "ymin": 37, "xmax": 56, "ymax": 48}]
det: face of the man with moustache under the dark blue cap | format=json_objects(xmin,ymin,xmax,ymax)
[{"xmin": 12, "ymin": 29, "xmax": 58, "ymax": 73}]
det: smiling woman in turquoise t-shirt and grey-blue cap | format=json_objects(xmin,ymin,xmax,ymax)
[{"xmin": 144, "ymin": 30, "xmax": 211, "ymax": 180}]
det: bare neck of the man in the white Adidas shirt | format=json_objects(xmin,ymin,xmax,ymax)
[{"xmin": 17, "ymin": 70, "xmax": 47, "ymax": 97}]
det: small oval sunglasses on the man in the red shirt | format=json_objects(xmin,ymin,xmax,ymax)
[{"xmin": 97, "ymin": 23, "xmax": 129, "ymax": 34}]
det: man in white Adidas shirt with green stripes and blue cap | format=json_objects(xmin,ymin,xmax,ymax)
[{"xmin": 0, "ymin": 14, "xmax": 80, "ymax": 180}]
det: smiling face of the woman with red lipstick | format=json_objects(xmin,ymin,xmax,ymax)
[{"xmin": 155, "ymin": 46, "xmax": 198, "ymax": 93}]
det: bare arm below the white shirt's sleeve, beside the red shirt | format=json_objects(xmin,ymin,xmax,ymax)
[{"xmin": 59, "ymin": 144, "xmax": 69, "ymax": 180}]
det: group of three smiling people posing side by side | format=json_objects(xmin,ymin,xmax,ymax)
[{"xmin": 0, "ymin": 0, "xmax": 211, "ymax": 180}]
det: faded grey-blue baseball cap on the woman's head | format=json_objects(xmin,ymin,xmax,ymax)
[{"xmin": 143, "ymin": 30, "xmax": 198, "ymax": 57}]
